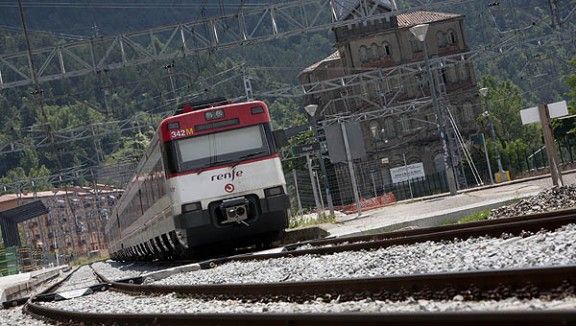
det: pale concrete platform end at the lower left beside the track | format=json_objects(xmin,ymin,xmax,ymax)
[{"xmin": 0, "ymin": 265, "xmax": 68, "ymax": 303}]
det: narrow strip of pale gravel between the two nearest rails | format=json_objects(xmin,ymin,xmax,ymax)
[{"xmin": 46, "ymin": 292, "xmax": 576, "ymax": 314}]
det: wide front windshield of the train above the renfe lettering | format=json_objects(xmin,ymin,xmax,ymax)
[{"xmin": 175, "ymin": 125, "xmax": 270, "ymax": 172}]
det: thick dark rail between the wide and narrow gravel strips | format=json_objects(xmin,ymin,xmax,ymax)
[{"xmin": 99, "ymin": 265, "xmax": 576, "ymax": 300}]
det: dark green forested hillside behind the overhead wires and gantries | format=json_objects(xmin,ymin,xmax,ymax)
[{"xmin": 0, "ymin": 0, "xmax": 576, "ymax": 187}]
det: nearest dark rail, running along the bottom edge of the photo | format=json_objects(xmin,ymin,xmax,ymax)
[{"xmin": 22, "ymin": 306, "xmax": 576, "ymax": 326}]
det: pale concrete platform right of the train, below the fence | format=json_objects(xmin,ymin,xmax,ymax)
[{"xmin": 321, "ymin": 171, "xmax": 576, "ymax": 236}]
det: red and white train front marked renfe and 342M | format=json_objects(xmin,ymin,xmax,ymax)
[{"xmin": 160, "ymin": 101, "xmax": 289, "ymax": 249}]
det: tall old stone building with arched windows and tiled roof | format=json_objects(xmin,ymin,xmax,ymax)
[{"xmin": 299, "ymin": 0, "xmax": 482, "ymax": 201}]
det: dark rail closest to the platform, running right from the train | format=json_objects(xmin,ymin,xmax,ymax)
[{"xmin": 200, "ymin": 209, "xmax": 576, "ymax": 269}]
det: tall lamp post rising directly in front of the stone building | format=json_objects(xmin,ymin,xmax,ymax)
[{"xmin": 410, "ymin": 24, "xmax": 457, "ymax": 196}]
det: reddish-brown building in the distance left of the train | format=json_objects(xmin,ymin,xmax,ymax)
[{"xmin": 0, "ymin": 186, "xmax": 122, "ymax": 257}]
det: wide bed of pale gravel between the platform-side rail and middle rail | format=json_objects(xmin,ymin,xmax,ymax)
[{"xmin": 150, "ymin": 224, "xmax": 576, "ymax": 285}]
